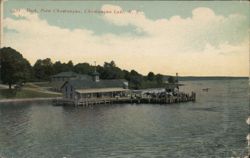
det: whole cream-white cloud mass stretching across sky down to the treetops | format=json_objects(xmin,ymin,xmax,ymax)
[{"xmin": 4, "ymin": 5, "xmax": 249, "ymax": 75}]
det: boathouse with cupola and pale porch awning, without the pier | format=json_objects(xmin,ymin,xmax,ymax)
[{"xmin": 61, "ymin": 72, "xmax": 128, "ymax": 100}]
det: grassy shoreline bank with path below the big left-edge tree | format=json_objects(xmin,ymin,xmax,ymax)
[{"xmin": 0, "ymin": 89, "xmax": 61, "ymax": 99}]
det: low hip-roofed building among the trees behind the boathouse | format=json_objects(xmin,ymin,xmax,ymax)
[{"xmin": 51, "ymin": 71, "xmax": 91, "ymax": 82}]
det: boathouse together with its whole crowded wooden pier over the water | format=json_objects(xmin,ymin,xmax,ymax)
[{"xmin": 53, "ymin": 71, "xmax": 196, "ymax": 106}]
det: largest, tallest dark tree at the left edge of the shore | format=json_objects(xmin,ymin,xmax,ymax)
[{"xmin": 0, "ymin": 47, "xmax": 31, "ymax": 89}]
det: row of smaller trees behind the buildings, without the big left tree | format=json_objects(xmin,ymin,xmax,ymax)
[{"xmin": 33, "ymin": 58, "xmax": 167, "ymax": 89}]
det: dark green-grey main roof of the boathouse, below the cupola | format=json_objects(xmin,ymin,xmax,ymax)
[{"xmin": 62, "ymin": 79, "xmax": 126, "ymax": 89}]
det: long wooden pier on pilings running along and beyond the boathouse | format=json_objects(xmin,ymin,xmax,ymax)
[{"xmin": 53, "ymin": 92, "xmax": 196, "ymax": 106}]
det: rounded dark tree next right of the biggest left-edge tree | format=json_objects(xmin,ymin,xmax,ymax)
[{"xmin": 33, "ymin": 58, "xmax": 54, "ymax": 81}]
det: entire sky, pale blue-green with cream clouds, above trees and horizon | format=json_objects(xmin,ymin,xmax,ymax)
[{"xmin": 2, "ymin": 0, "xmax": 250, "ymax": 76}]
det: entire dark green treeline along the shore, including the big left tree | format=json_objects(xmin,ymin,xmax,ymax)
[{"xmin": 0, "ymin": 47, "xmax": 175, "ymax": 89}]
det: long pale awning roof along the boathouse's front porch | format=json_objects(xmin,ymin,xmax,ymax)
[{"xmin": 76, "ymin": 88, "xmax": 128, "ymax": 94}]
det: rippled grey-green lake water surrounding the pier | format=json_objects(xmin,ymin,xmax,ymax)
[{"xmin": 0, "ymin": 79, "xmax": 249, "ymax": 158}]
